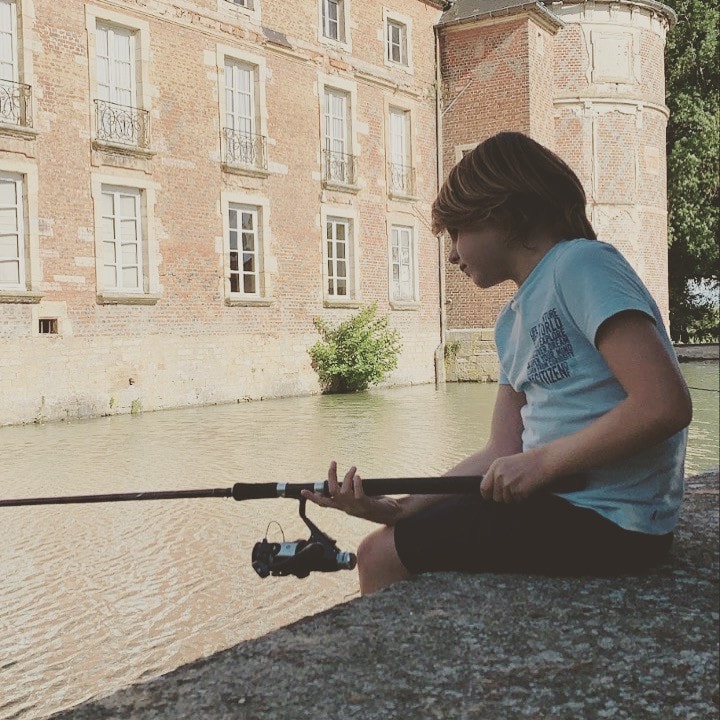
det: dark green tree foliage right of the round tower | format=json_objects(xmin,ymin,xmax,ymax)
[{"xmin": 665, "ymin": 0, "xmax": 720, "ymax": 342}]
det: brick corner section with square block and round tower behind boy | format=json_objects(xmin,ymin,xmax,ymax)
[{"xmin": 438, "ymin": 0, "xmax": 675, "ymax": 380}]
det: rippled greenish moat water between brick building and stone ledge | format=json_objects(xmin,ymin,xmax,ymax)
[{"xmin": 0, "ymin": 363, "xmax": 718, "ymax": 720}]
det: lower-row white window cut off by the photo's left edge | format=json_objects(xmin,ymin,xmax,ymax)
[{"xmin": 0, "ymin": 173, "xmax": 27, "ymax": 291}]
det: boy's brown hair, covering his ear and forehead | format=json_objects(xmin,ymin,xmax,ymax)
[{"xmin": 432, "ymin": 132, "xmax": 596, "ymax": 243}]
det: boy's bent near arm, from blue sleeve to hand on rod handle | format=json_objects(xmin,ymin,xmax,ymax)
[{"xmin": 481, "ymin": 311, "xmax": 692, "ymax": 502}]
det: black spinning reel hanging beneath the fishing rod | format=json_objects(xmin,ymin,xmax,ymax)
[{"xmin": 252, "ymin": 498, "xmax": 357, "ymax": 578}]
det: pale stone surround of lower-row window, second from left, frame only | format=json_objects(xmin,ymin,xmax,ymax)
[{"xmin": 91, "ymin": 173, "xmax": 162, "ymax": 305}]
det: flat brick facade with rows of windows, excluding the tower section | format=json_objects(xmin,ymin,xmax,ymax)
[{"xmin": 0, "ymin": 0, "xmax": 448, "ymax": 425}]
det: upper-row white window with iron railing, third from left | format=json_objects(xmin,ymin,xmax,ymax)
[{"xmin": 224, "ymin": 59, "xmax": 267, "ymax": 168}]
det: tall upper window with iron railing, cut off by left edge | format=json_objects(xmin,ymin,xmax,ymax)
[{"xmin": 0, "ymin": 0, "xmax": 32, "ymax": 127}]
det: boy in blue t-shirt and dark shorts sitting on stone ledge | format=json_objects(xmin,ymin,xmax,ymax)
[{"xmin": 306, "ymin": 133, "xmax": 692, "ymax": 594}]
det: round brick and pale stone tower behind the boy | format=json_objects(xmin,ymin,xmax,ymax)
[{"xmin": 546, "ymin": 0, "xmax": 676, "ymax": 322}]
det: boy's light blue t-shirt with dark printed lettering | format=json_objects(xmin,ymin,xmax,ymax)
[{"xmin": 495, "ymin": 240, "xmax": 687, "ymax": 535}]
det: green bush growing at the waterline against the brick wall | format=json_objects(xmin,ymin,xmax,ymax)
[{"xmin": 308, "ymin": 303, "xmax": 402, "ymax": 393}]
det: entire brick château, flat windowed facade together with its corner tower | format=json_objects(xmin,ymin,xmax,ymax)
[{"xmin": 0, "ymin": 0, "xmax": 674, "ymax": 425}]
